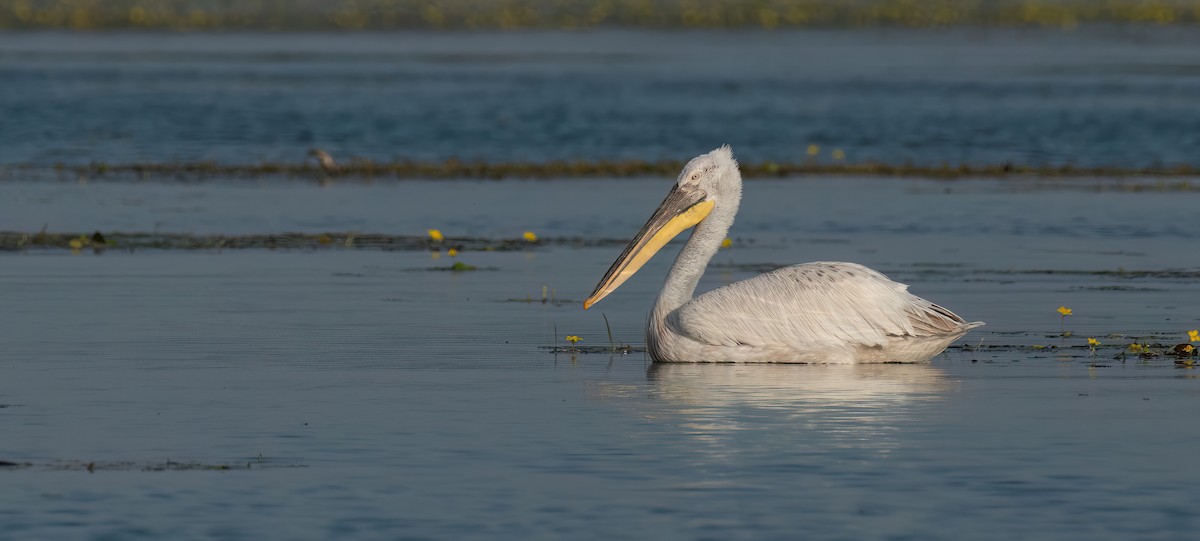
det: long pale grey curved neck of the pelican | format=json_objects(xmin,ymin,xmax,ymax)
[{"xmin": 653, "ymin": 198, "xmax": 738, "ymax": 319}]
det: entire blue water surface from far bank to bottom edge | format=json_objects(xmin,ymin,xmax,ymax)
[{"xmin": 0, "ymin": 28, "xmax": 1200, "ymax": 541}]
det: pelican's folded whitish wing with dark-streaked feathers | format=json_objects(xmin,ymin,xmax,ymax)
[{"xmin": 668, "ymin": 262, "xmax": 974, "ymax": 350}]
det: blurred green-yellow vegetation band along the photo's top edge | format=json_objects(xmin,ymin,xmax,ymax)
[{"xmin": 7, "ymin": 0, "xmax": 1200, "ymax": 31}]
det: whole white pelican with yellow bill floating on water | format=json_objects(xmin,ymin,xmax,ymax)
[{"xmin": 583, "ymin": 145, "xmax": 983, "ymax": 363}]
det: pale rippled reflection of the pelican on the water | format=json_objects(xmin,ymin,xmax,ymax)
[{"xmin": 647, "ymin": 363, "xmax": 953, "ymax": 450}]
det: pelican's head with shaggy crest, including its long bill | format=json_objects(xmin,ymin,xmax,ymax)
[{"xmin": 583, "ymin": 145, "xmax": 742, "ymax": 309}]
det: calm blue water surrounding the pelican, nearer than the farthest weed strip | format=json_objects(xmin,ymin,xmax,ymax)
[{"xmin": 0, "ymin": 180, "xmax": 1200, "ymax": 540}]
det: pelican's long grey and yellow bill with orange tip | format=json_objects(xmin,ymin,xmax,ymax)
[{"xmin": 583, "ymin": 185, "xmax": 714, "ymax": 309}]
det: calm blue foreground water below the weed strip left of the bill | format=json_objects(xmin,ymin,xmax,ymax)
[{"xmin": 0, "ymin": 247, "xmax": 1200, "ymax": 540}]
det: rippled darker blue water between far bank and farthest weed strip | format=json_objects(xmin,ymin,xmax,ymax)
[{"xmin": 0, "ymin": 26, "xmax": 1200, "ymax": 167}]
